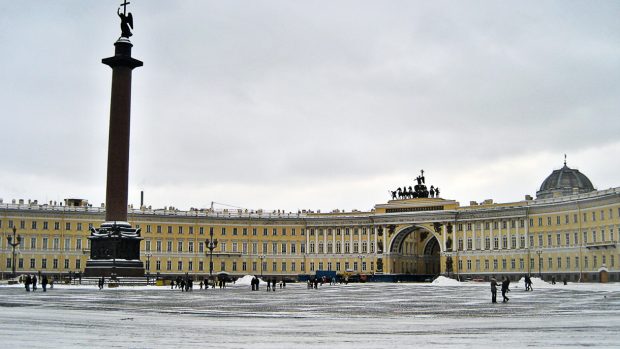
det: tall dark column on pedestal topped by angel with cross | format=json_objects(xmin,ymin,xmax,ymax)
[{"xmin": 84, "ymin": 0, "xmax": 144, "ymax": 277}]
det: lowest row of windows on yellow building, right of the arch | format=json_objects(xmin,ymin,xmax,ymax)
[{"xmin": 458, "ymin": 255, "xmax": 616, "ymax": 272}]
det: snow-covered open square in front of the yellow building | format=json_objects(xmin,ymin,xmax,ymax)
[{"xmin": 0, "ymin": 279, "xmax": 620, "ymax": 349}]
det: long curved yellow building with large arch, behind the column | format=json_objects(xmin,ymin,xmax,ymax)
[{"xmin": 0, "ymin": 165, "xmax": 620, "ymax": 282}]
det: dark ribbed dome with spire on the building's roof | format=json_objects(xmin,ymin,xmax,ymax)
[{"xmin": 536, "ymin": 161, "xmax": 595, "ymax": 199}]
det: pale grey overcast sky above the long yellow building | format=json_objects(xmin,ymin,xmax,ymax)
[{"xmin": 0, "ymin": 0, "xmax": 620, "ymax": 211}]
